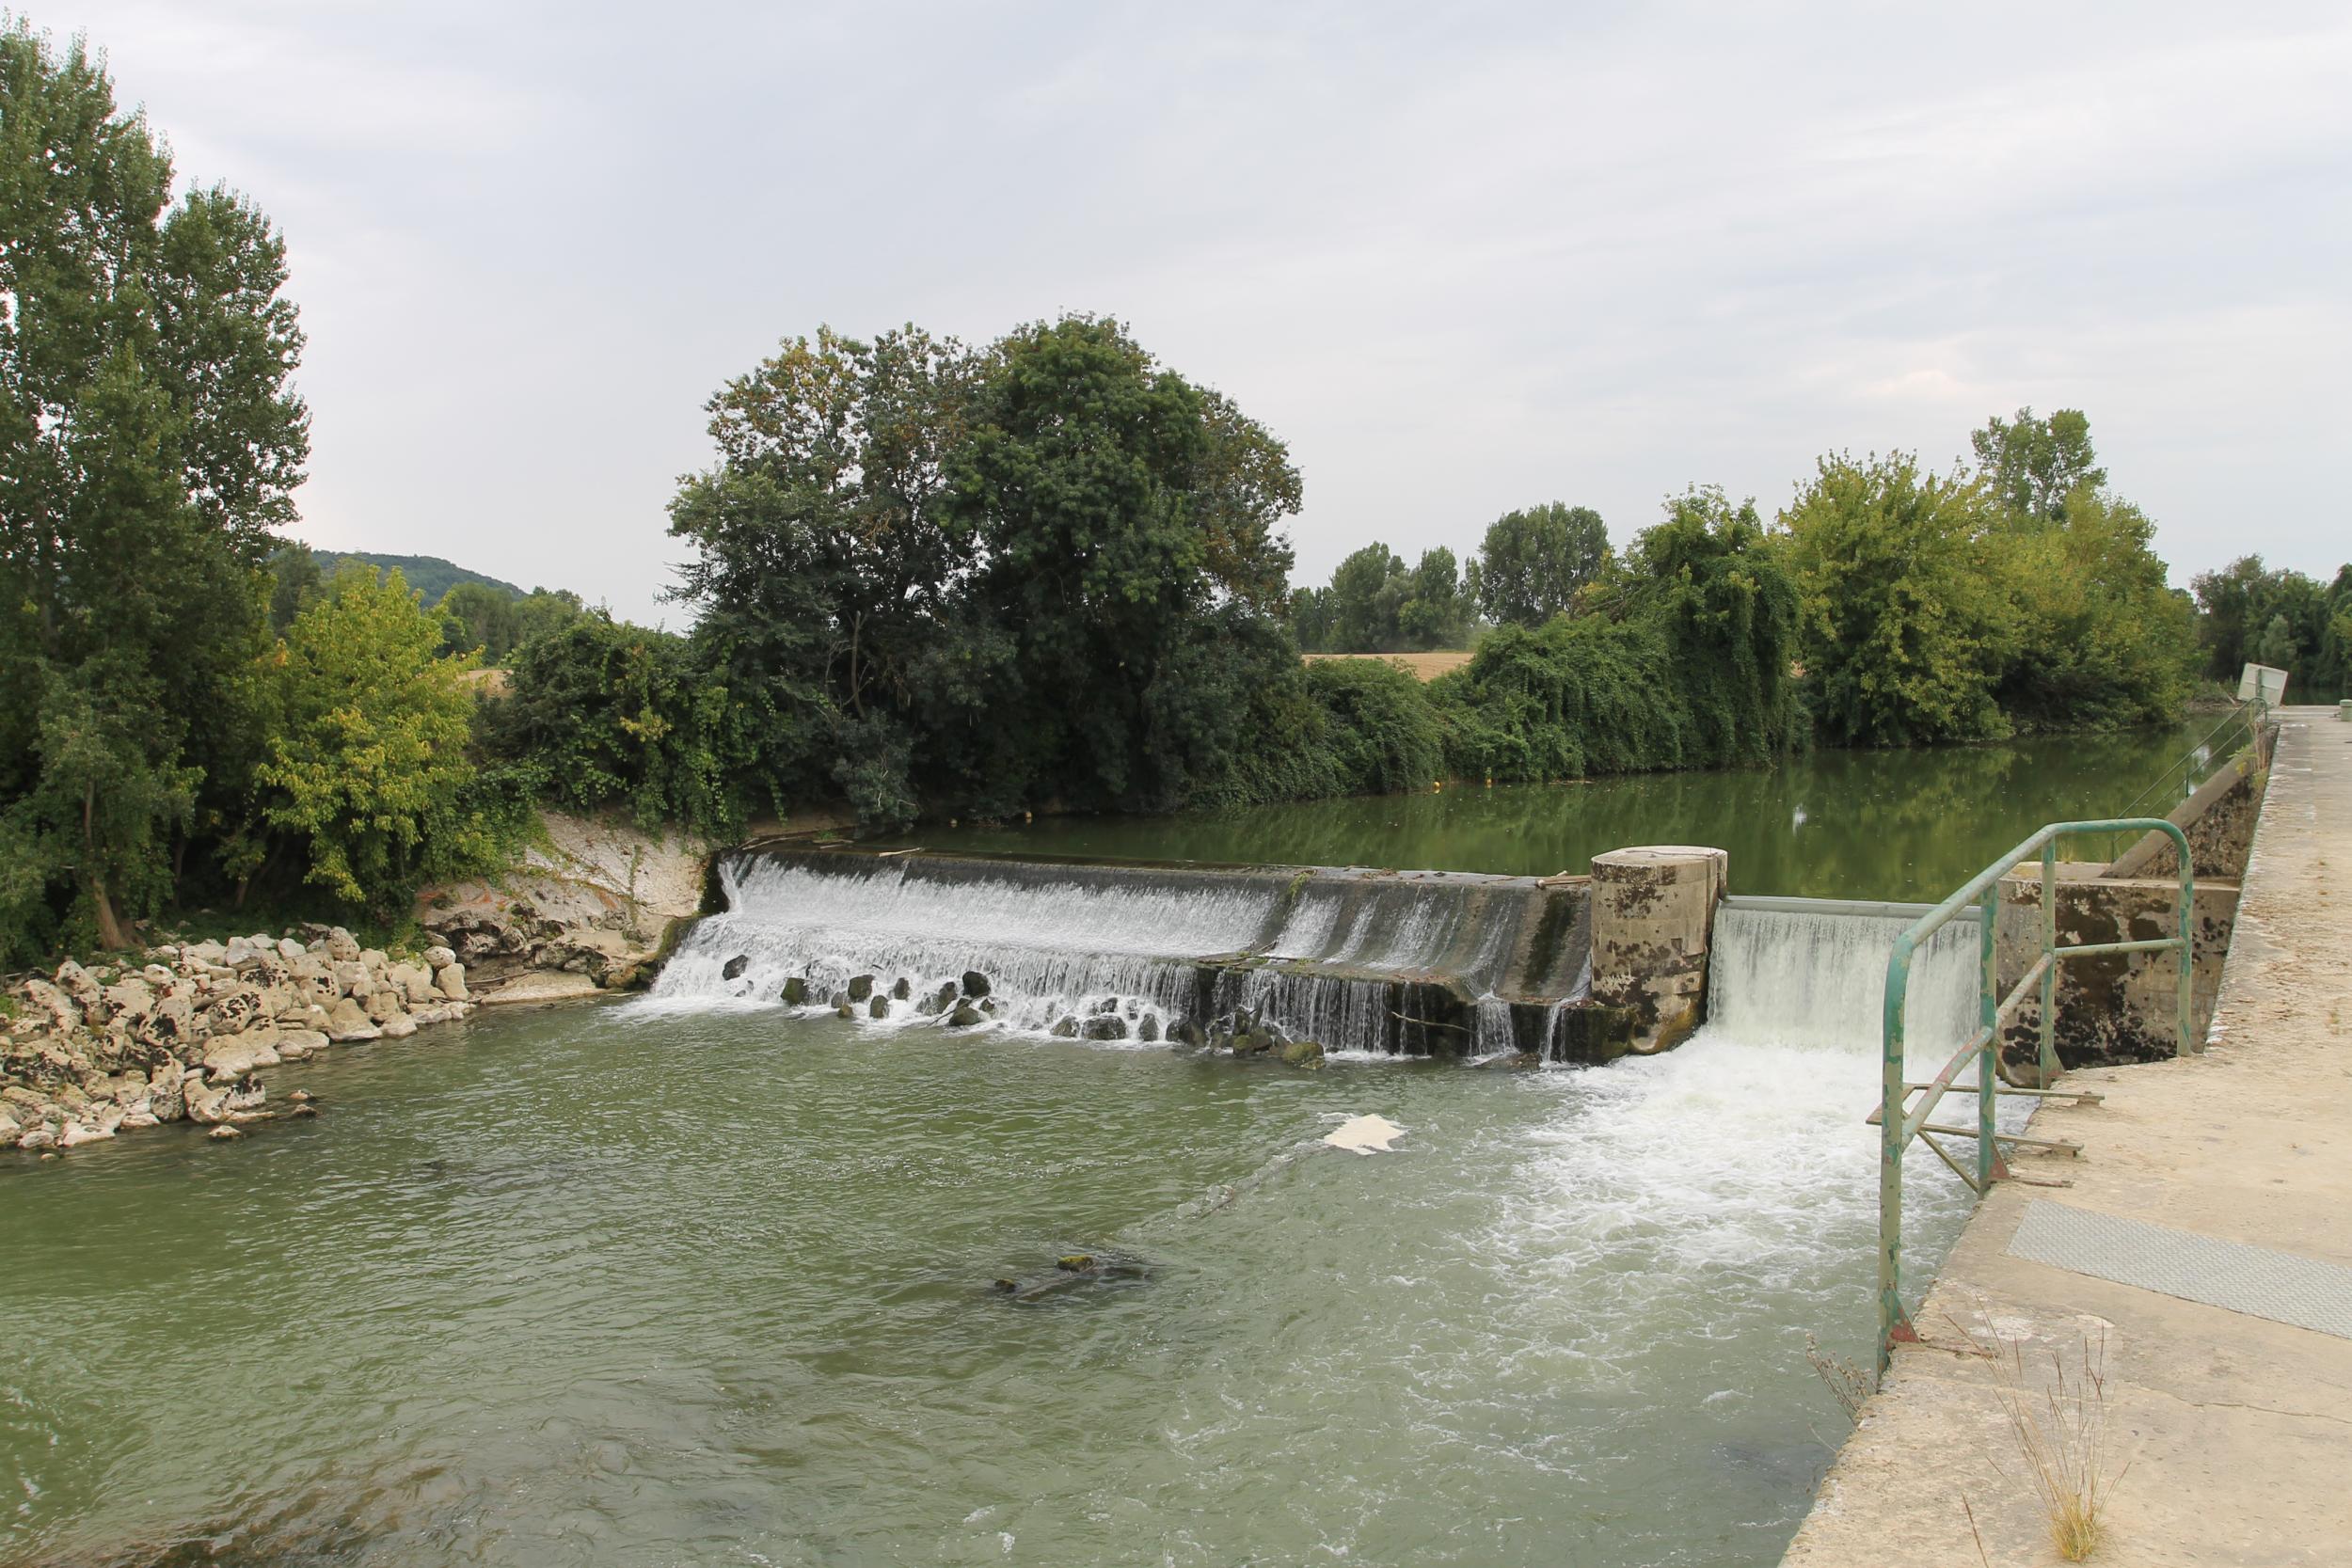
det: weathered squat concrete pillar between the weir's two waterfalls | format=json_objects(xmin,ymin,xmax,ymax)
[{"xmin": 1593, "ymin": 844, "xmax": 1729, "ymax": 1051}]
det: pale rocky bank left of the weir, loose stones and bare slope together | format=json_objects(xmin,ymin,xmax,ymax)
[{"xmin": 0, "ymin": 814, "xmax": 708, "ymax": 1154}]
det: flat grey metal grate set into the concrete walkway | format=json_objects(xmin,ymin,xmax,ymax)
[{"xmin": 2009, "ymin": 1199, "xmax": 2352, "ymax": 1340}]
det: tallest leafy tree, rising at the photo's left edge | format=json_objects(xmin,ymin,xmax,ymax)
[{"xmin": 0, "ymin": 24, "xmax": 309, "ymax": 945}]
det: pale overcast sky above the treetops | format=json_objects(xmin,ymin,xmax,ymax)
[{"xmin": 32, "ymin": 0, "xmax": 2352, "ymax": 626}]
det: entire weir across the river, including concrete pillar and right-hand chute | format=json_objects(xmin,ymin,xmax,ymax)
[{"xmin": 654, "ymin": 847, "xmax": 2004, "ymax": 1063}]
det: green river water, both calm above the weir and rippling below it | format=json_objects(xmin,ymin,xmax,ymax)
[{"xmin": 0, "ymin": 736, "xmax": 2178, "ymax": 1568}]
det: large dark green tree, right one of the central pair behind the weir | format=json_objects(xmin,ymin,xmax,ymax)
[{"xmin": 953, "ymin": 317, "xmax": 1298, "ymax": 806}]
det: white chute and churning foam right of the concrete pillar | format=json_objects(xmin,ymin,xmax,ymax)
[{"xmin": 1491, "ymin": 910, "xmax": 1985, "ymax": 1383}]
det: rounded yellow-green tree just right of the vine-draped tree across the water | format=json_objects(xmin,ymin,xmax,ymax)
[{"xmin": 1781, "ymin": 451, "xmax": 2016, "ymax": 745}]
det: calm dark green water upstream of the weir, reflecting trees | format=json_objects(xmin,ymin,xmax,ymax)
[{"xmin": 898, "ymin": 724, "xmax": 2211, "ymax": 900}]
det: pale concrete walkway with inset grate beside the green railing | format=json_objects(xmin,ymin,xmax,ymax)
[{"xmin": 1786, "ymin": 707, "xmax": 2352, "ymax": 1568}]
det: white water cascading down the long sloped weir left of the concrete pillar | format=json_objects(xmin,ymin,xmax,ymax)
[{"xmin": 654, "ymin": 851, "xmax": 1590, "ymax": 1053}]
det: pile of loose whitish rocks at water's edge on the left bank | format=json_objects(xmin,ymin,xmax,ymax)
[{"xmin": 0, "ymin": 927, "xmax": 473, "ymax": 1152}]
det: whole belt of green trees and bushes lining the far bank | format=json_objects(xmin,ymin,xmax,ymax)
[{"xmin": 0, "ymin": 21, "xmax": 2352, "ymax": 964}]
